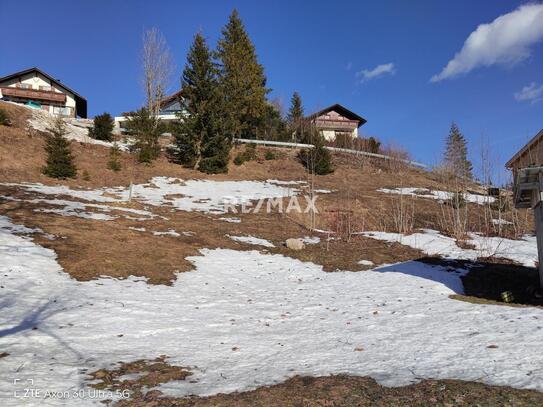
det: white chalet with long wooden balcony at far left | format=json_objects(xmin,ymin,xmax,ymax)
[{"xmin": 0, "ymin": 68, "xmax": 87, "ymax": 118}]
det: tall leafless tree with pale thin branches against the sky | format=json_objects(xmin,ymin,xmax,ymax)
[{"xmin": 142, "ymin": 28, "xmax": 175, "ymax": 117}]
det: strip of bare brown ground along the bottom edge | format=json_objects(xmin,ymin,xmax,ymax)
[{"xmin": 112, "ymin": 376, "xmax": 543, "ymax": 407}]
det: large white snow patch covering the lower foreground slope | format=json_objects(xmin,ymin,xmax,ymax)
[{"xmin": 0, "ymin": 217, "xmax": 543, "ymax": 406}]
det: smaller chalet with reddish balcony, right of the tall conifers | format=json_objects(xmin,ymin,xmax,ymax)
[{"xmin": 306, "ymin": 103, "xmax": 366, "ymax": 141}]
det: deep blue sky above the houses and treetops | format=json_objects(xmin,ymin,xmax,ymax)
[{"xmin": 0, "ymin": 0, "xmax": 543, "ymax": 181}]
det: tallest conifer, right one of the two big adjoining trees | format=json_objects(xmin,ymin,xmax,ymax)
[{"xmin": 216, "ymin": 10, "xmax": 269, "ymax": 138}]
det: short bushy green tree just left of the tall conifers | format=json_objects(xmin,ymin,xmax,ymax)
[{"xmin": 125, "ymin": 107, "xmax": 164, "ymax": 164}]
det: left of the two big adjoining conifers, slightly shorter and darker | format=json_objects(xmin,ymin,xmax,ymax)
[{"xmin": 172, "ymin": 34, "xmax": 231, "ymax": 173}]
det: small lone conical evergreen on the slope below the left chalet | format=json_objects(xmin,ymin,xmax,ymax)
[{"xmin": 42, "ymin": 117, "xmax": 77, "ymax": 179}]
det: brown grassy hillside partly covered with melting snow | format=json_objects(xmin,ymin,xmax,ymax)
[{"xmin": 0, "ymin": 102, "xmax": 543, "ymax": 405}]
